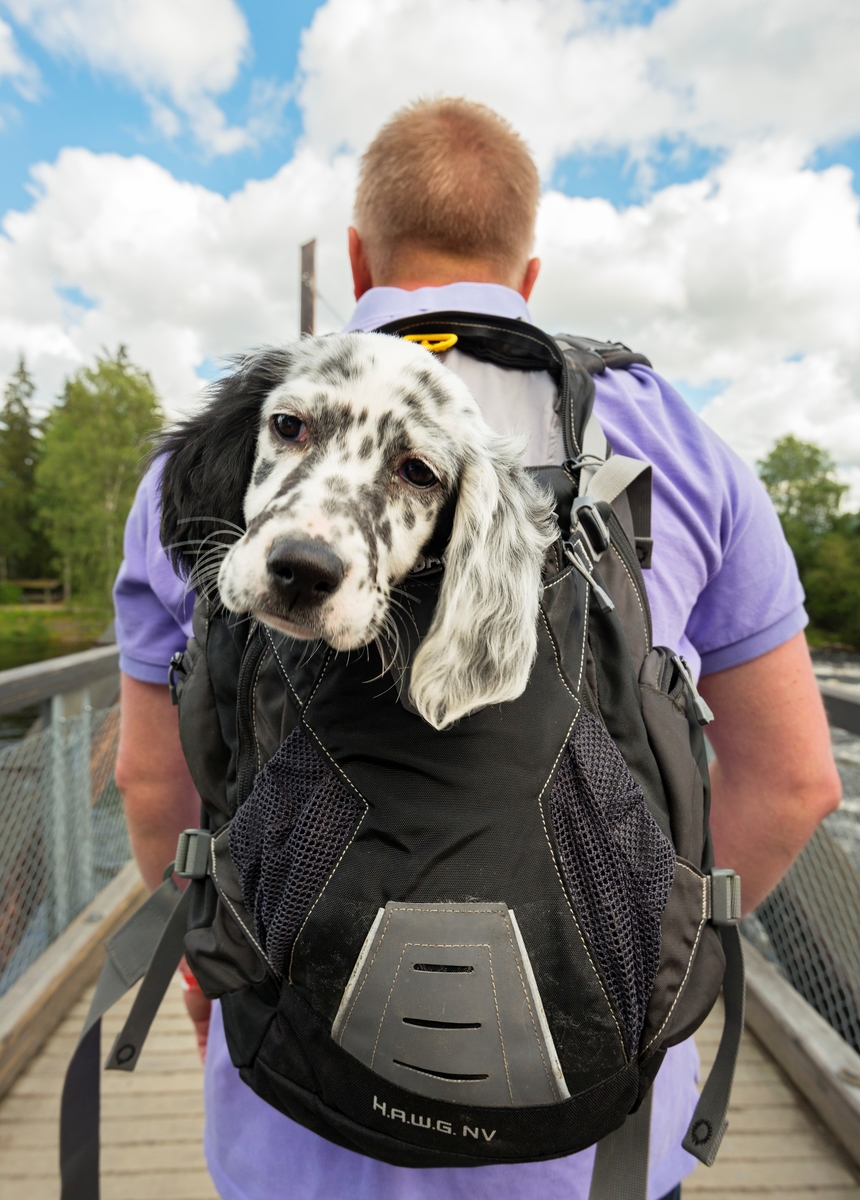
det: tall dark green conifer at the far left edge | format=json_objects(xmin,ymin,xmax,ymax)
[{"xmin": 0, "ymin": 355, "xmax": 49, "ymax": 578}]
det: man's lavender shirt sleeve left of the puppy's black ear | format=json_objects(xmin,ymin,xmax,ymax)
[{"xmin": 114, "ymin": 462, "xmax": 194, "ymax": 684}]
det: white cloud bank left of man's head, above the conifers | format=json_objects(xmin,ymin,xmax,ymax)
[{"xmin": 0, "ymin": 149, "xmax": 354, "ymax": 412}]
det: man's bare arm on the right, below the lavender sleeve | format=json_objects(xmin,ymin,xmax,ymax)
[{"xmin": 699, "ymin": 632, "xmax": 841, "ymax": 912}]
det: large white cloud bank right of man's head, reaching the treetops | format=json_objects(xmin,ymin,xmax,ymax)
[{"xmin": 533, "ymin": 143, "xmax": 860, "ymax": 504}]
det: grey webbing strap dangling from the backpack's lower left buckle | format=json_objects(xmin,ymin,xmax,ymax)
[{"xmin": 60, "ymin": 864, "xmax": 188, "ymax": 1200}]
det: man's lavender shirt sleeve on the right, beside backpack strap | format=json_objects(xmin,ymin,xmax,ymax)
[{"xmin": 595, "ymin": 365, "xmax": 807, "ymax": 674}]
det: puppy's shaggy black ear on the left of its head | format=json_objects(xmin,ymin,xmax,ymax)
[{"xmin": 159, "ymin": 349, "xmax": 291, "ymax": 577}]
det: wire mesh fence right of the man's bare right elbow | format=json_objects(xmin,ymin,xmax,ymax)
[{"xmin": 741, "ymin": 730, "xmax": 860, "ymax": 1051}]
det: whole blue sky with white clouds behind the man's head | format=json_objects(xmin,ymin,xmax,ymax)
[{"xmin": 0, "ymin": 0, "xmax": 860, "ymax": 494}]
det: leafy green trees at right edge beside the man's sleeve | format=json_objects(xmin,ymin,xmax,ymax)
[{"xmin": 758, "ymin": 436, "xmax": 860, "ymax": 647}]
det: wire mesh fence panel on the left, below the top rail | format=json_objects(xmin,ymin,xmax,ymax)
[{"xmin": 0, "ymin": 706, "xmax": 131, "ymax": 995}]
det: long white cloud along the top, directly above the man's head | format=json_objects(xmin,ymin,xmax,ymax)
[{"xmin": 300, "ymin": 0, "xmax": 860, "ymax": 173}]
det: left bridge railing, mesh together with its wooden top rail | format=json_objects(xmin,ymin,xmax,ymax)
[{"xmin": 0, "ymin": 646, "xmax": 131, "ymax": 995}]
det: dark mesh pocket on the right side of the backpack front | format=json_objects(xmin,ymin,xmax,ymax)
[{"xmin": 549, "ymin": 709, "xmax": 675, "ymax": 1057}]
